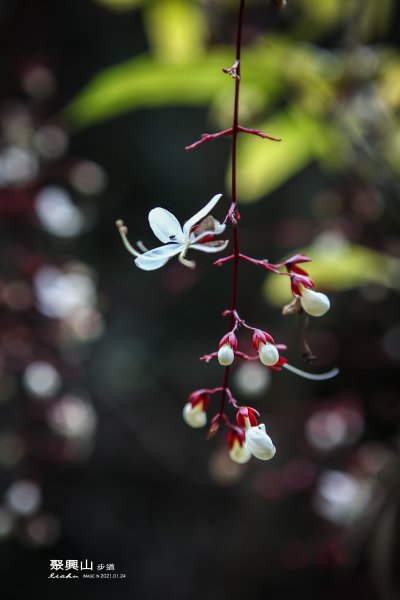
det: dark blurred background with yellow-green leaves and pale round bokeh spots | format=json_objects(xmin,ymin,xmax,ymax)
[{"xmin": 0, "ymin": 0, "xmax": 400, "ymax": 600}]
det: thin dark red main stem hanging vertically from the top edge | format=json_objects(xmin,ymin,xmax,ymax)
[{"xmin": 219, "ymin": 0, "xmax": 245, "ymax": 414}]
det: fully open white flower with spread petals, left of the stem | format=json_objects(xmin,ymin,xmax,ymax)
[{"xmin": 117, "ymin": 194, "xmax": 229, "ymax": 271}]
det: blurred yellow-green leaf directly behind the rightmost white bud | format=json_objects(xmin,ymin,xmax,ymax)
[{"xmin": 263, "ymin": 235, "xmax": 400, "ymax": 306}]
